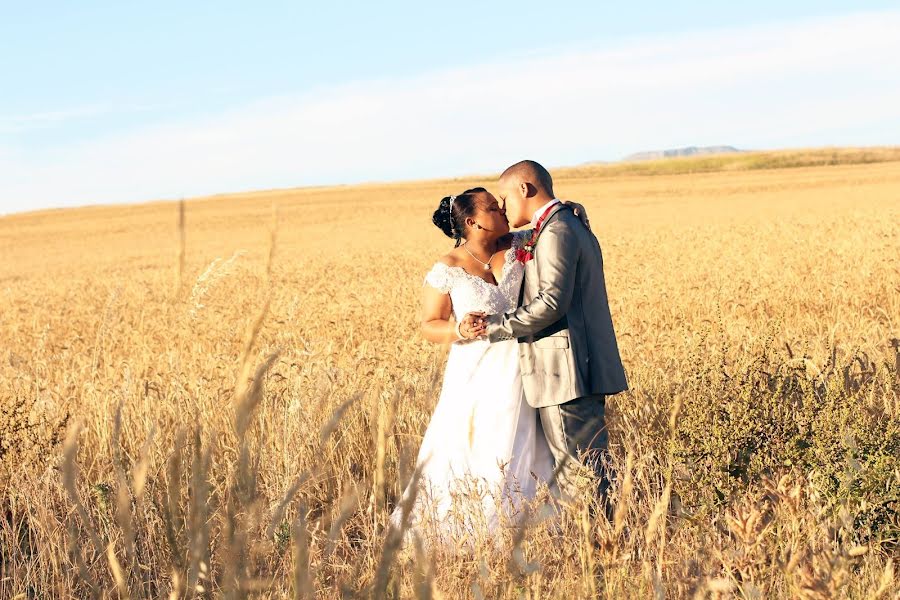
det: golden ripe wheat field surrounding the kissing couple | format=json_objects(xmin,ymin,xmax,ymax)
[{"xmin": 0, "ymin": 149, "xmax": 900, "ymax": 599}]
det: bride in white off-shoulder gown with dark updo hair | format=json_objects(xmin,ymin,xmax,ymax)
[{"xmin": 391, "ymin": 187, "xmax": 583, "ymax": 545}]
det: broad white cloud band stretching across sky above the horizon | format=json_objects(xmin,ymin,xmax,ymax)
[{"xmin": 0, "ymin": 11, "xmax": 900, "ymax": 211}]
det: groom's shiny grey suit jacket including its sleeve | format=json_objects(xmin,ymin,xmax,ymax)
[{"xmin": 487, "ymin": 205, "xmax": 628, "ymax": 408}]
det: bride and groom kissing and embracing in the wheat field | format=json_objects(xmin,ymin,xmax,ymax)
[{"xmin": 391, "ymin": 160, "xmax": 628, "ymax": 546}]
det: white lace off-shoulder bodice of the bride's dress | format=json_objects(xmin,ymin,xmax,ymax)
[{"xmin": 425, "ymin": 232, "xmax": 525, "ymax": 320}]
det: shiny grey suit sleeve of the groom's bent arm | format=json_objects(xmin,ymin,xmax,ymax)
[{"xmin": 487, "ymin": 219, "xmax": 579, "ymax": 342}]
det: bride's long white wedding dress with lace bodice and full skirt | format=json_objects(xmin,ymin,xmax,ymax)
[{"xmin": 391, "ymin": 232, "xmax": 553, "ymax": 545}]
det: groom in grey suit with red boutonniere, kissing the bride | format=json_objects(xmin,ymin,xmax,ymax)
[{"xmin": 466, "ymin": 160, "xmax": 628, "ymax": 516}]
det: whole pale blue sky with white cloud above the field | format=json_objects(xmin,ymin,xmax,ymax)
[{"xmin": 0, "ymin": 0, "xmax": 900, "ymax": 213}]
